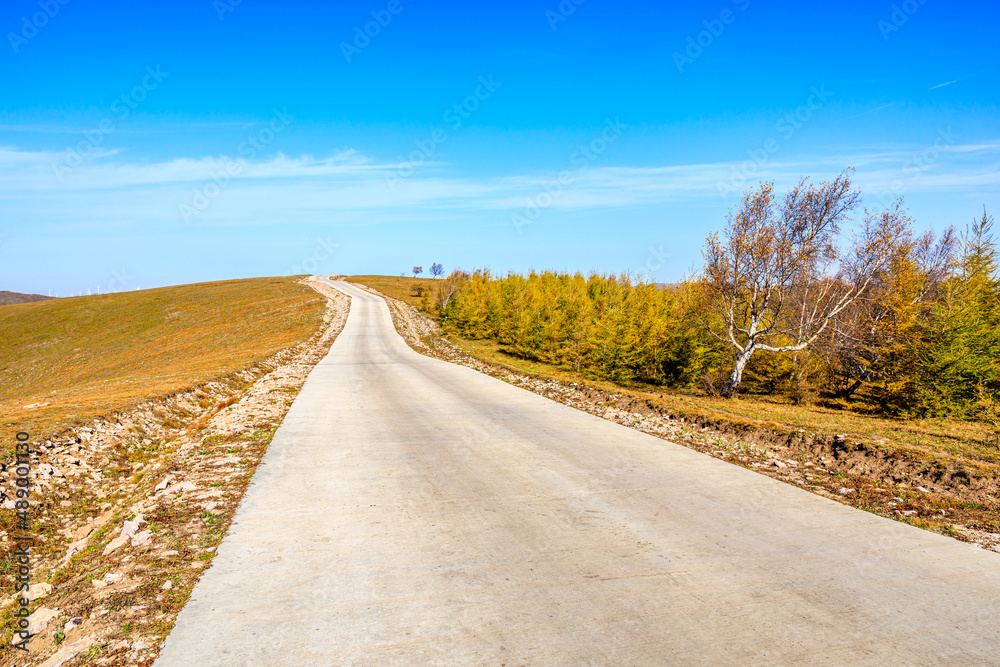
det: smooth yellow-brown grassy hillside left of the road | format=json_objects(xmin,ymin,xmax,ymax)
[{"xmin": 0, "ymin": 278, "xmax": 324, "ymax": 441}]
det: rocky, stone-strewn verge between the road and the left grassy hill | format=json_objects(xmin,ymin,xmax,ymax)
[{"xmin": 0, "ymin": 282, "xmax": 350, "ymax": 667}]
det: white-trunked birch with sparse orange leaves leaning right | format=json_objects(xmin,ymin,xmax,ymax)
[{"xmin": 703, "ymin": 170, "xmax": 909, "ymax": 397}]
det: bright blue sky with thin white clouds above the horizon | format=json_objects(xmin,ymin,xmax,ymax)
[{"xmin": 0, "ymin": 0, "xmax": 1000, "ymax": 295}]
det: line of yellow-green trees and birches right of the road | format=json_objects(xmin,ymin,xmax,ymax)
[{"xmin": 432, "ymin": 170, "xmax": 1000, "ymax": 422}]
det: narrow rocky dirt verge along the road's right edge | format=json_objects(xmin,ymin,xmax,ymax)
[{"xmin": 356, "ymin": 285, "xmax": 1000, "ymax": 565}]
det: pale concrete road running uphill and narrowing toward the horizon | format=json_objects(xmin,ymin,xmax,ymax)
[{"xmin": 156, "ymin": 283, "xmax": 1000, "ymax": 667}]
